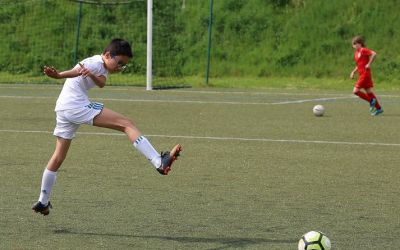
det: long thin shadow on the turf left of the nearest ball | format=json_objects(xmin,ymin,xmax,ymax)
[{"xmin": 53, "ymin": 229, "xmax": 297, "ymax": 250}]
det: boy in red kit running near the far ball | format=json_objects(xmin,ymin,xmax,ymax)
[{"xmin": 350, "ymin": 36, "xmax": 383, "ymax": 116}]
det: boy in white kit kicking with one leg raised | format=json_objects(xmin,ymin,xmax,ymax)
[{"xmin": 32, "ymin": 39, "xmax": 182, "ymax": 215}]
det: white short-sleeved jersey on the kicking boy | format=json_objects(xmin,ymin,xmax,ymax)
[{"xmin": 55, "ymin": 55, "xmax": 108, "ymax": 111}]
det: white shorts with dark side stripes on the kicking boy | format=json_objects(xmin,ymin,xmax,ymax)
[{"xmin": 53, "ymin": 102, "xmax": 104, "ymax": 139}]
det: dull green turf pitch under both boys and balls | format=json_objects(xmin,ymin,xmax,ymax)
[{"xmin": 0, "ymin": 84, "xmax": 400, "ymax": 250}]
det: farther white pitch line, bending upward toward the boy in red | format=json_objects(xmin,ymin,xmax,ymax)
[{"xmin": 0, "ymin": 96, "xmax": 355, "ymax": 105}]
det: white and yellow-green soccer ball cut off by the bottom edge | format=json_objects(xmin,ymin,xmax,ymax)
[{"xmin": 298, "ymin": 231, "xmax": 331, "ymax": 250}]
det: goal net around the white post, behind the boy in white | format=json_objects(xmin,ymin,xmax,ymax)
[{"xmin": 0, "ymin": 0, "xmax": 185, "ymax": 88}]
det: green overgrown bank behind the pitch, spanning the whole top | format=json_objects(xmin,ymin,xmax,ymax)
[{"xmin": 0, "ymin": 0, "xmax": 400, "ymax": 85}]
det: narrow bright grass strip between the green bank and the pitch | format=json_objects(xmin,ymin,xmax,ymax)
[{"xmin": 0, "ymin": 72, "xmax": 400, "ymax": 92}]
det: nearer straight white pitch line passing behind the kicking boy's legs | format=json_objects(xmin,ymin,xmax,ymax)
[{"xmin": 0, "ymin": 129, "xmax": 400, "ymax": 147}]
